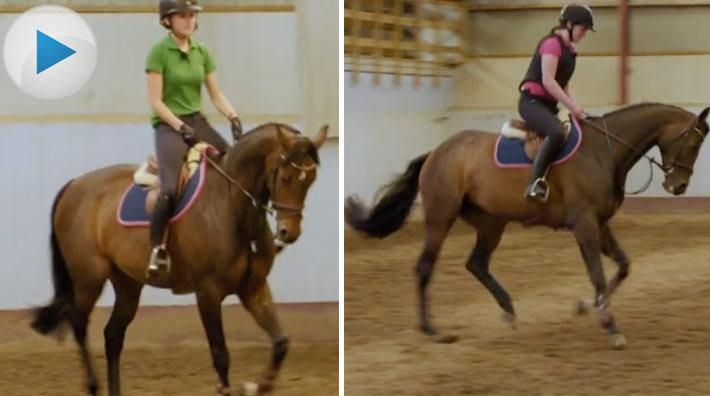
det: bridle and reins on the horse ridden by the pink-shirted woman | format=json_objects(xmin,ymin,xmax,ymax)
[{"xmin": 582, "ymin": 116, "xmax": 705, "ymax": 195}]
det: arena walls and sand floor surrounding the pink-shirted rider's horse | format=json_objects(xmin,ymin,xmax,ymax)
[{"xmin": 344, "ymin": 0, "xmax": 710, "ymax": 396}]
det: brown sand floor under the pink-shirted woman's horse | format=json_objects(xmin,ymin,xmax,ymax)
[{"xmin": 345, "ymin": 214, "xmax": 710, "ymax": 396}]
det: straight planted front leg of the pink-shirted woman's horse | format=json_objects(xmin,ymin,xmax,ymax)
[{"xmin": 573, "ymin": 215, "xmax": 626, "ymax": 349}]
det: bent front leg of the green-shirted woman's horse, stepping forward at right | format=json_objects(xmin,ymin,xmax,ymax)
[{"xmin": 238, "ymin": 281, "xmax": 289, "ymax": 394}]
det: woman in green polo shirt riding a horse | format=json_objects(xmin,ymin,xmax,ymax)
[{"xmin": 145, "ymin": 0, "xmax": 242, "ymax": 275}]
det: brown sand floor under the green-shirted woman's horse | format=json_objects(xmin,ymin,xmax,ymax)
[{"xmin": 0, "ymin": 304, "xmax": 338, "ymax": 396}]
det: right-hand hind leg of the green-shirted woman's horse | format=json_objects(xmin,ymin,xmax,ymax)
[{"xmin": 104, "ymin": 267, "xmax": 143, "ymax": 396}]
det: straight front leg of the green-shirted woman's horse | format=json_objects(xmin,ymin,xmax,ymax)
[{"xmin": 195, "ymin": 280, "xmax": 230, "ymax": 395}]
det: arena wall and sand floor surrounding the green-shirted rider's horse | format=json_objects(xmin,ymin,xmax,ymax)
[{"xmin": 0, "ymin": 0, "xmax": 339, "ymax": 396}]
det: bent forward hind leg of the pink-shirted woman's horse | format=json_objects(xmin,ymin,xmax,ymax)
[{"xmin": 462, "ymin": 213, "xmax": 515, "ymax": 327}]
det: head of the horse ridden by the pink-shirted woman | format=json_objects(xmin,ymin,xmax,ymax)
[{"xmin": 658, "ymin": 107, "xmax": 710, "ymax": 195}]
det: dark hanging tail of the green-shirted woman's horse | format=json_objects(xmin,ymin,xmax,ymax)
[{"xmin": 32, "ymin": 181, "xmax": 74, "ymax": 334}]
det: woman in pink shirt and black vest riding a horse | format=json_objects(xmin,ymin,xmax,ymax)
[{"xmin": 518, "ymin": 4, "xmax": 594, "ymax": 201}]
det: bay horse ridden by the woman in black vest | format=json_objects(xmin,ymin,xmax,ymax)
[{"xmin": 345, "ymin": 103, "xmax": 710, "ymax": 348}]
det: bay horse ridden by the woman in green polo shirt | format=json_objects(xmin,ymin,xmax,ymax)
[{"xmin": 32, "ymin": 123, "xmax": 328, "ymax": 396}]
